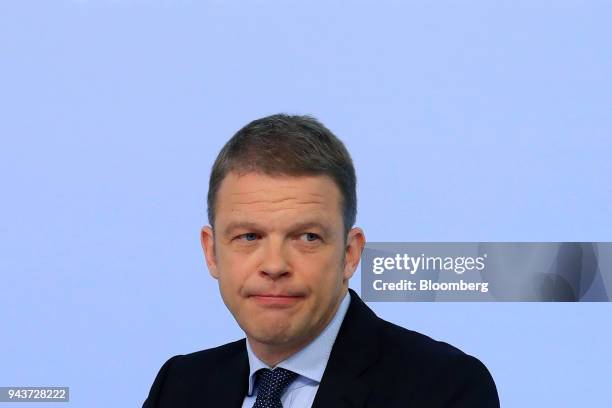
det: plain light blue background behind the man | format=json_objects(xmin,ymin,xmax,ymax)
[{"xmin": 0, "ymin": 0, "xmax": 612, "ymax": 408}]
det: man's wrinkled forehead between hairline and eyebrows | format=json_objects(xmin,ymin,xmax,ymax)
[{"xmin": 215, "ymin": 172, "xmax": 342, "ymax": 225}]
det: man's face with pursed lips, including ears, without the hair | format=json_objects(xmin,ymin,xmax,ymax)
[{"xmin": 202, "ymin": 172, "xmax": 364, "ymax": 354}]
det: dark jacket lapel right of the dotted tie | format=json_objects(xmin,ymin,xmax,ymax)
[{"xmin": 312, "ymin": 289, "xmax": 380, "ymax": 408}]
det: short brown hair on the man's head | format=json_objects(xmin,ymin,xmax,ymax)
[{"xmin": 208, "ymin": 114, "xmax": 357, "ymax": 233}]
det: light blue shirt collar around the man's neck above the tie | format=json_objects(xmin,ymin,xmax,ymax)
[{"xmin": 246, "ymin": 293, "xmax": 351, "ymax": 395}]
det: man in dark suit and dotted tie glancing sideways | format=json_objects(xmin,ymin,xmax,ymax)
[{"xmin": 144, "ymin": 115, "xmax": 499, "ymax": 408}]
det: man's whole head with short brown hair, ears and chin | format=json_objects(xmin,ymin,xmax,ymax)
[{"xmin": 202, "ymin": 115, "xmax": 365, "ymax": 361}]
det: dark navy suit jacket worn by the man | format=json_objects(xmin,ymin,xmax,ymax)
[{"xmin": 143, "ymin": 290, "xmax": 499, "ymax": 408}]
